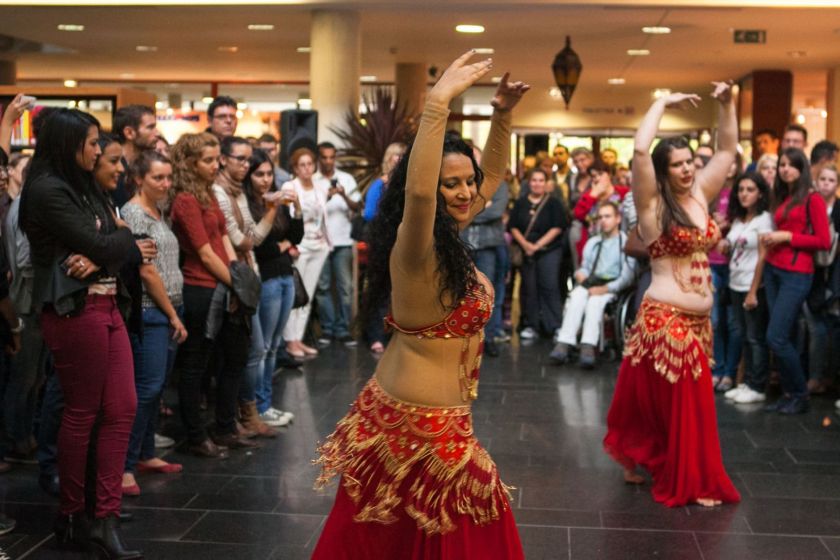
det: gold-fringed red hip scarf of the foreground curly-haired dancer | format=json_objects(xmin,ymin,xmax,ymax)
[{"xmin": 315, "ymin": 378, "xmax": 509, "ymax": 535}]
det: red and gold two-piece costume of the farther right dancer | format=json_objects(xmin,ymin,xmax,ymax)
[{"xmin": 604, "ymin": 218, "xmax": 741, "ymax": 507}]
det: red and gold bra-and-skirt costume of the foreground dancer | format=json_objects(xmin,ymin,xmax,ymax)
[{"xmin": 312, "ymin": 284, "xmax": 523, "ymax": 560}]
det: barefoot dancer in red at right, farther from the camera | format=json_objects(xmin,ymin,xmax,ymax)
[{"xmin": 604, "ymin": 83, "xmax": 741, "ymax": 507}]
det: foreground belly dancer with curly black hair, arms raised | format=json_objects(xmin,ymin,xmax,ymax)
[{"xmin": 313, "ymin": 51, "xmax": 529, "ymax": 560}]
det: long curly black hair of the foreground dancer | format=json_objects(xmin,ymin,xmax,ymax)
[{"xmin": 359, "ymin": 134, "xmax": 484, "ymax": 326}]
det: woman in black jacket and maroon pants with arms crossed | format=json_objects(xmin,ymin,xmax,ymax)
[{"xmin": 20, "ymin": 109, "xmax": 155, "ymax": 560}]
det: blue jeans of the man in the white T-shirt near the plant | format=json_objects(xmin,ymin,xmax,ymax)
[{"xmin": 315, "ymin": 247, "xmax": 353, "ymax": 338}]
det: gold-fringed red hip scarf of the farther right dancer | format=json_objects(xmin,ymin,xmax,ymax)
[{"xmin": 624, "ymin": 297, "xmax": 714, "ymax": 383}]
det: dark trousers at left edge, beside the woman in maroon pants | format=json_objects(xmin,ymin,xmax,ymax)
[{"xmin": 4, "ymin": 313, "xmax": 47, "ymax": 453}]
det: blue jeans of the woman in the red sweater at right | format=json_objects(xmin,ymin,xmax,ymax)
[{"xmin": 764, "ymin": 263, "xmax": 813, "ymax": 397}]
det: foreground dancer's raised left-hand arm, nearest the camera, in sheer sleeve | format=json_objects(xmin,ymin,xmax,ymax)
[{"xmin": 392, "ymin": 50, "xmax": 491, "ymax": 271}]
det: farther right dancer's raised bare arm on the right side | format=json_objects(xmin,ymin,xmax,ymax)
[{"xmin": 696, "ymin": 82, "xmax": 738, "ymax": 202}]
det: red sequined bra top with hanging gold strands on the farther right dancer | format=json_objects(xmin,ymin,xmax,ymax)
[{"xmin": 648, "ymin": 216, "xmax": 720, "ymax": 296}]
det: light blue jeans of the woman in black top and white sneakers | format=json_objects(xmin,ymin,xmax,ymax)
[{"xmin": 249, "ymin": 276, "xmax": 295, "ymax": 414}]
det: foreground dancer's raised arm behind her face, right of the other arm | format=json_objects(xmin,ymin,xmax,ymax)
[{"xmin": 470, "ymin": 72, "xmax": 531, "ymax": 217}]
